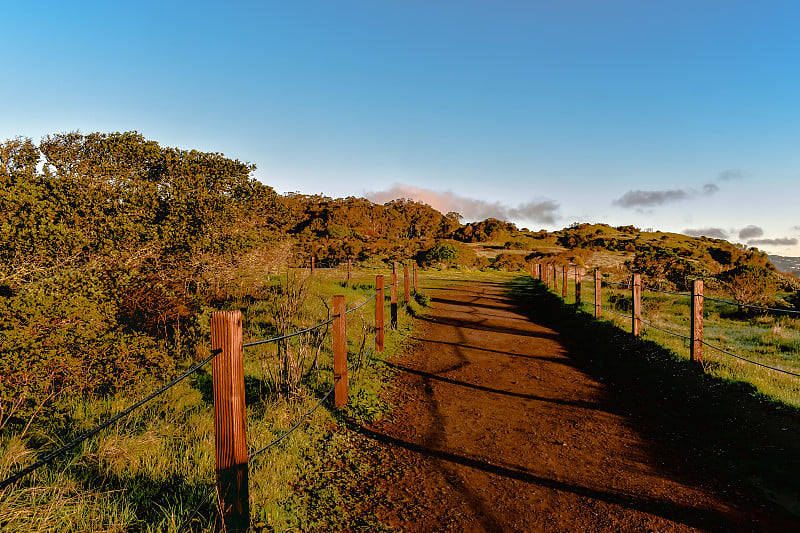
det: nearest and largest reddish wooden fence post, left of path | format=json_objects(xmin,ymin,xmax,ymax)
[{"xmin": 211, "ymin": 311, "xmax": 250, "ymax": 531}]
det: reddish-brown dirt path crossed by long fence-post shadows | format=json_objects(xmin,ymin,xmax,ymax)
[{"xmin": 362, "ymin": 282, "xmax": 800, "ymax": 532}]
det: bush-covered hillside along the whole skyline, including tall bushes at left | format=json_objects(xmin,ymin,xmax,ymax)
[{"xmin": 0, "ymin": 132, "xmax": 797, "ymax": 414}]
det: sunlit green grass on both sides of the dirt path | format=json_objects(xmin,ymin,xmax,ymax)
[{"xmin": 0, "ymin": 269, "xmax": 800, "ymax": 532}]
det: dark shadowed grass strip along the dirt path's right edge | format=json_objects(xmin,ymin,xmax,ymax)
[{"xmin": 509, "ymin": 277, "xmax": 800, "ymax": 520}]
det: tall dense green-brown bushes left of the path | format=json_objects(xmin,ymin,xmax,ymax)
[{"xmin": 0, "ymin": 132, "xmax": 284, "ymax": 427}]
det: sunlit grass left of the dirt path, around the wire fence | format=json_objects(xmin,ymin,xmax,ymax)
[{"xmin": 0, "ymin": 264, "xmax": 420, "ymax": 532}]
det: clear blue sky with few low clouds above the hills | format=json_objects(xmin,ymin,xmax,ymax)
[{"xmin": 0, "ymin": 0, "xmax": 800, "ymax": 256}]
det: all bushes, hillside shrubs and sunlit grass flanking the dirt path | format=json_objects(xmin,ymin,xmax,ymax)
[{"xmin": 0, "ymin": 132, "xmax": 800, "ymax": 531}]
